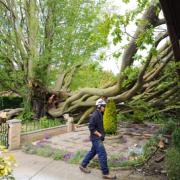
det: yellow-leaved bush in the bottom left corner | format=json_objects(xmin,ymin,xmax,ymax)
[{"xmin": 0, "ymin": 146, "xmax": 16, "ymax": 179}]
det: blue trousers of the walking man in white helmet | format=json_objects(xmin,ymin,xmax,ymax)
[{"xmin": 81, "ymin": 139, "xmax": 109, "ymax": 175}]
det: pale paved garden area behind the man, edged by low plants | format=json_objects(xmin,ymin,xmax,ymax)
[{"xmin": 35, "ymin": 123, "xmax": 159, "ymax": 156}]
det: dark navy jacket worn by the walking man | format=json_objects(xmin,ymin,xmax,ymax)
[{"xmin": 89, "ymin": 110, "xmax": 105, "ymax": 141}]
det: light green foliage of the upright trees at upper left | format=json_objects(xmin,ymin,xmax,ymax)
[{"xmin": 0, "ymin": 0, "xmax": 111, "ymax": 95}]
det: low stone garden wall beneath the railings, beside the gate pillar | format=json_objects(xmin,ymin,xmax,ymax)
[{"xmin": 20, "ymin": 125, "xmax": 67, "ymax": 144}]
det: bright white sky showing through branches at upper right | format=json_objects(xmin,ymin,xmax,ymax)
[{"xmin": 101, "ymin": 0, "xmax": 169, "ymax": 74}]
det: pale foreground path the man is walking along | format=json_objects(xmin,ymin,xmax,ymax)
[{"xmin": 12, "ymin": 150, "xmax": 164, "ymax": 180}]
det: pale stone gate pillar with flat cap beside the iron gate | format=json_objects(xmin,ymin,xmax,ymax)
[{"xmin": 7, "ymin": 119, "xmax": 21, "ymax": 150}]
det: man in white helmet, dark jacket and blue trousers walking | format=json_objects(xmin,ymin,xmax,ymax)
[{"xmin": 79, "ymin": 99, "xmax": 116, "ymax": 179}]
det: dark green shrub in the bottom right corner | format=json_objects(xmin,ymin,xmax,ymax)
[{"xmin": 165, "ymin": 148, "xmax": 180, "ymax": 180}]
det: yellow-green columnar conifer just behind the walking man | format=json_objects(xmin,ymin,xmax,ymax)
[{"xmin": 104, "ymin": 100, "xmax": 117, "ymax": 134}]
